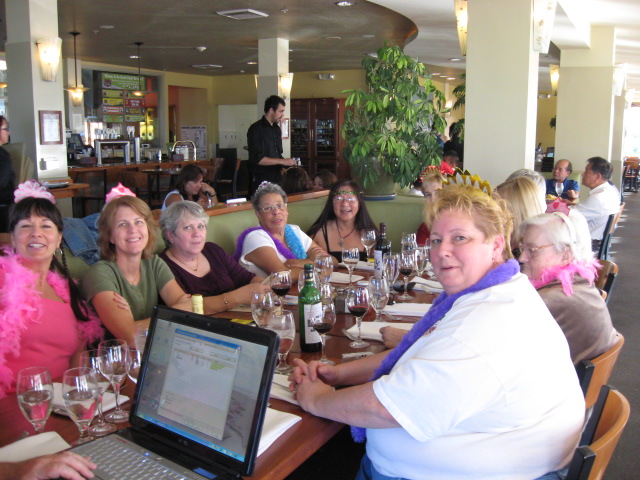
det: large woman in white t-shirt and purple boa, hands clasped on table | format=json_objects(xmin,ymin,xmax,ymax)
[{"xmin": 291, "ymin": 185, "xmax": 584, "ymax": 480}]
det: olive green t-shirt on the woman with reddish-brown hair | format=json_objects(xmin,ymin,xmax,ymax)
[{"xmin": 81, "ymin": 255, "xmax": 174, "ymax": 320}]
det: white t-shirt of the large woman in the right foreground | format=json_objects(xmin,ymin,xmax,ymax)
[{"xmin": 367, "ymin": 274, "xmax": 584, "ymax": 480}]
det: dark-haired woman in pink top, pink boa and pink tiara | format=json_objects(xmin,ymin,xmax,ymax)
[{"xmin": 0, "ymin": 180, "xmax": 103, "ymax": 398}]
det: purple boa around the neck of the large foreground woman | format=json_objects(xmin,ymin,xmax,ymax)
[{"xmin": 351, "ymin": 260, "xmax": 520, "ymax": 442}]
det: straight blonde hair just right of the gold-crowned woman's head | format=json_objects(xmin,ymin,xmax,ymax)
[{"xmin": 496, "ymin": 177, "xmax": 544, "ymax": 248}]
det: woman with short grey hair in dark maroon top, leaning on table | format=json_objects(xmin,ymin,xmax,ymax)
[{"xmin": 160, "ymin": 200, "xmax": 270, "ymax": 313}]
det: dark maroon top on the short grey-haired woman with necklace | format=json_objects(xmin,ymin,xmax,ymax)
[{"xmin": 160, "ymin": 242, "xmax": 255, "ymax": 297}]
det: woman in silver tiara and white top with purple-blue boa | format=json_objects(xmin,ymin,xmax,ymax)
[{"xmin": 234, "ymin": 182, "xmax": 324, "ymax": 278}]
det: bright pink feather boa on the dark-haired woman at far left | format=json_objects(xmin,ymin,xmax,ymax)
[{"xmin": 0, "ymin": 249, "xmax": 104, "ymax": 398}]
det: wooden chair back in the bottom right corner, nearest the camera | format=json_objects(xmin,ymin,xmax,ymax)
[{"xmin": 566, "ymin": 385, "xmax": 631, "ymax": 480}]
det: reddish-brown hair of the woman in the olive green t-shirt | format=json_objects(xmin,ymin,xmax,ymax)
[{"xmin": 98, "ymin": 195, "xmax": 156, "ymax": 262}]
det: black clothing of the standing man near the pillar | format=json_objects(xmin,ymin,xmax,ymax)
[{"xmin": 247, "ymin": 116, "xmax": 284, "ymax": 190}]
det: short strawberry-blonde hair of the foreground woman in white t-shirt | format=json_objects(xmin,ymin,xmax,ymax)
[{"xmin": 425, "ymin": 184, "xmax": 513, "ymax": 260}]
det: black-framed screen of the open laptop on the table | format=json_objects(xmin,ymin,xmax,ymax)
[{"xmin": 131, "ymin": 307, "xmax": 277, "ymax": 474}]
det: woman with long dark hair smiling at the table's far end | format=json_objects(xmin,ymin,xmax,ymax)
[{"xmin": 307, "ymin": 180, "xmax": 378, "ymax": 262}]
